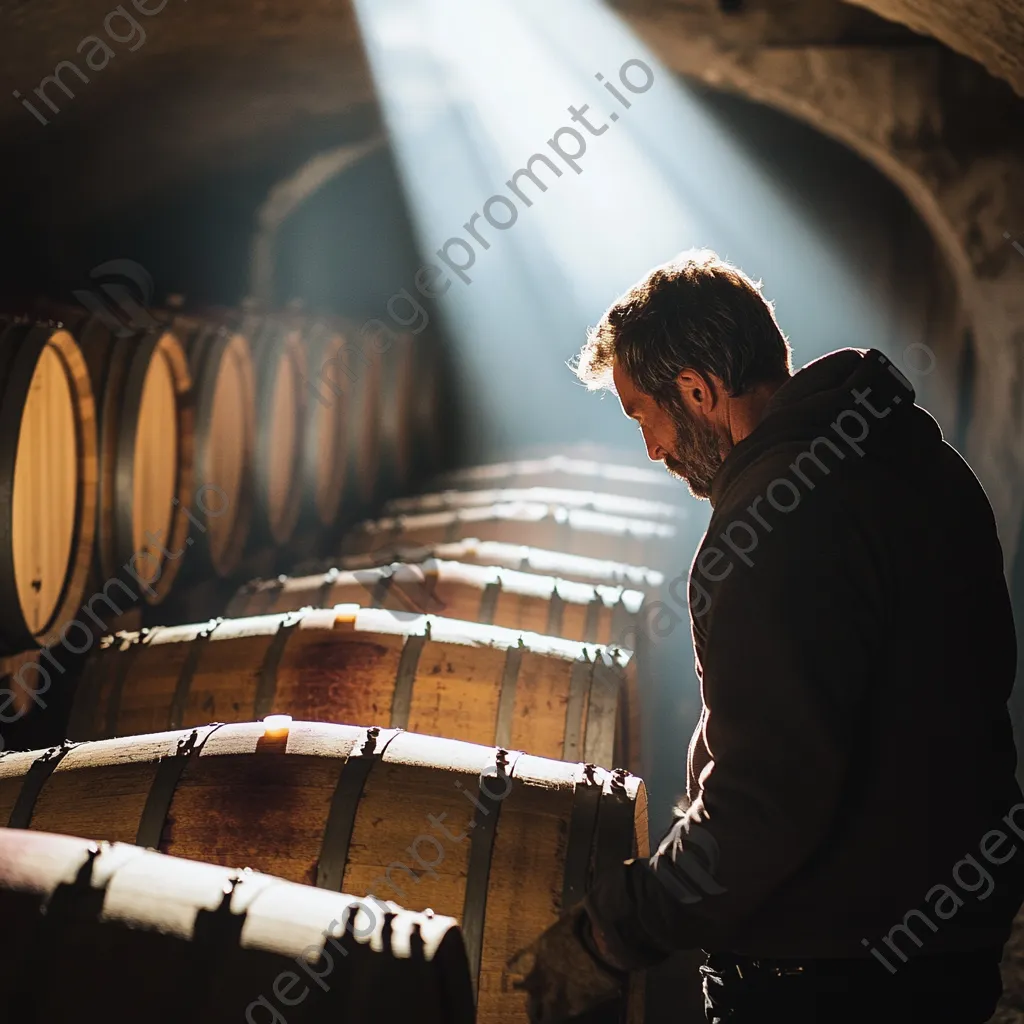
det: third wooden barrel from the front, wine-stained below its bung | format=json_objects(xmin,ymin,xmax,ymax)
[{"xmin": 68, "ymin": 604, "xmax": 640, "ymax": 767}]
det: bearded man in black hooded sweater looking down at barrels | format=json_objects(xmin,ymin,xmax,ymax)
[{"xmin": 520, "ymin": 251, "xmax": 1024, "ymax": 1024}]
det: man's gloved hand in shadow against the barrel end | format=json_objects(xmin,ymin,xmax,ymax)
[{"xmin": 509, "ymin": 903, "xmax": 629, "ymax": 1024}]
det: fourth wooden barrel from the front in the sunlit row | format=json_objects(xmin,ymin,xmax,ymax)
[{"xmin": 227, "ymin": 558, "xmax": 644, "ymax": 646}]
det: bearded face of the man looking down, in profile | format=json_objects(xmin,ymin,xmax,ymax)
[{"xmin": 612, "ymin": 362, "xmax": 729, "ymax": 498}]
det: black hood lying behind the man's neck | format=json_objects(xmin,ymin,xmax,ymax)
[{"xmin": 711, "ymin": 348, "xmax": 942, "ymax": 507}]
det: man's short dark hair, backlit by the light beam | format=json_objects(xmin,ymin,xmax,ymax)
[{"xmin": 572, "ymin": 249, "xmax": 791, "ymax": 409}]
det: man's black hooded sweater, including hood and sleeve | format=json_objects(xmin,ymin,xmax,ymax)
[{"xmin": 590, "ymin": 349, "xmax": 1024, "ymax": 966}]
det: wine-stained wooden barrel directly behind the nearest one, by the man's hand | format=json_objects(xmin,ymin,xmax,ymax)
[{"xmin": 0, "ymin": 722, "xmax": 648, "ymax": 1024}]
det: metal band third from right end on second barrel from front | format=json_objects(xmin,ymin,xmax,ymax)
[{"xmin": 462, "ymin": 749, "xmax": 520, "ymax": 1001}]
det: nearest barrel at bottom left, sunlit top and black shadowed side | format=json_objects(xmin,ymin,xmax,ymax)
[{"xmin": 0, "ymin": 828, "xmax": 473, "ymax": 1024}]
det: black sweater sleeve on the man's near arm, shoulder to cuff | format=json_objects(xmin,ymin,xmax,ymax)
[{"xmin": 590, "ymin": 479, "xmax": 884, "ymax": 967}]
